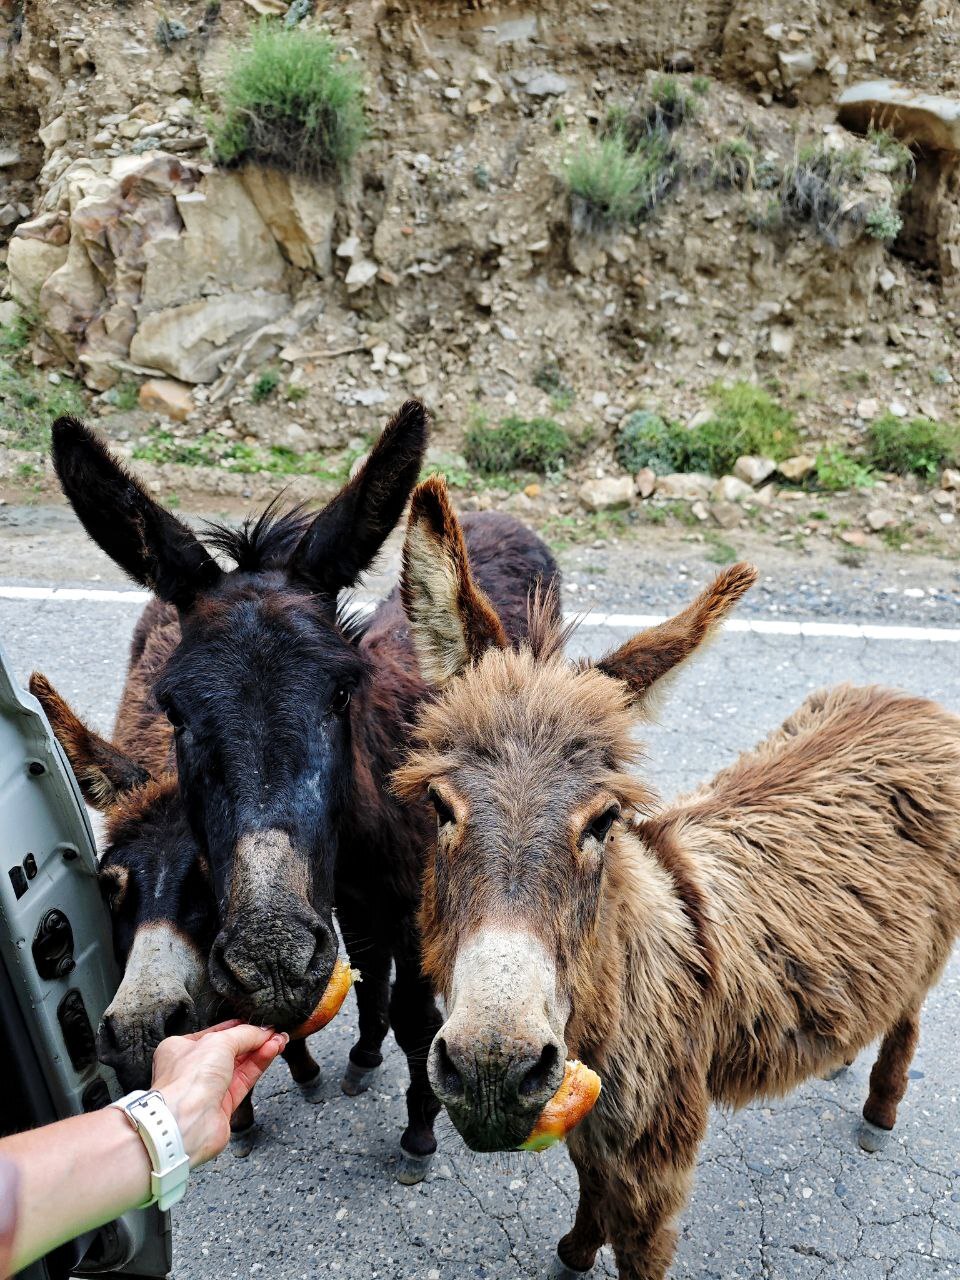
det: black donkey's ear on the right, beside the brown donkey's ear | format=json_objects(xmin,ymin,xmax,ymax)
[{"xmin": 289, "ymin": 401, "xmax": 428, "ymax": 596}]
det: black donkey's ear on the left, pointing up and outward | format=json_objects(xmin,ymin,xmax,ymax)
[{"xmin": 52, "ymin": 417, "xmax": 221, "ymax": 609}]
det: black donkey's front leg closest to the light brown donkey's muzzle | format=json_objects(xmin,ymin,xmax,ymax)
[{"xmin": 390, "ymin": 947, "xmax": 443, "ymax": 1185}]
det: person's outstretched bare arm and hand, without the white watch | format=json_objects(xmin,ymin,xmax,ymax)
[{"xmin": 0, "ymin": 1023, "xmax": 287, "ymax": 1276}]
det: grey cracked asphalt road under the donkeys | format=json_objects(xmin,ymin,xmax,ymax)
[{"xmin": 0, "ymin": 581, "xmax": 960, "ymax": 1280}]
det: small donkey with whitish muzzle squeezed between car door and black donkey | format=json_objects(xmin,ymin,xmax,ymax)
[{"xmin": 29, "ymin": 600, "xmax": 319, "ymax": 1130}]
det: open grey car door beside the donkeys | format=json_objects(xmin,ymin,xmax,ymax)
[{"xmin": 0, "ymin": 648, "xmax": 172, "ymax": 1280}]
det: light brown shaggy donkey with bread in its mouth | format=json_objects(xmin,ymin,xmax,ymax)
[{"xmin": 396, "ymin": 481, "xmax": 960, "ymax": 1280}]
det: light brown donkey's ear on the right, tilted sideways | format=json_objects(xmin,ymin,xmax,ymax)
[{"xmin": 596, "ymin": 564, "xmax": 758, "ymax": 703}]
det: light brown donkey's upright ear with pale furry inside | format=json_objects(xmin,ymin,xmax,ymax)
[{"xmin": 401, "ymin": 476, "xmax": 507, "ymax": 685}]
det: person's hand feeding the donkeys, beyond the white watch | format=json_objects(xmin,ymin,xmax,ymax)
[{"xmin": 152, "ymin": 1019, "xmax": 289, "ymax": 1169}]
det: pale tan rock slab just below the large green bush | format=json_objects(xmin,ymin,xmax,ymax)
[{"xmin": 241, "ymin": 165, "xmax": 342, "ymax": 275}]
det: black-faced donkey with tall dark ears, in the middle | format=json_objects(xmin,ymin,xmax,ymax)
[{"xmin": 54, "ymin": 402, "xmax": 556, "ymax": 1181}]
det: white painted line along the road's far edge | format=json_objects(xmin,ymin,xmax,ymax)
[{"xmin": 0, "ymin": 586, "xmax": 960, "ymax": 644}]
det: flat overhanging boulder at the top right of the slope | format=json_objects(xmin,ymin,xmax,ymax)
[{"xmin": 837, "ymin": 79, "xmax": 960, "ymax": 152}]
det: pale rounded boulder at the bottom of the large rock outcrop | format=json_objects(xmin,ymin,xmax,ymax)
[{"xmin": 129, "ymin": 289, "xmax": 289, "ymax": 383}]
